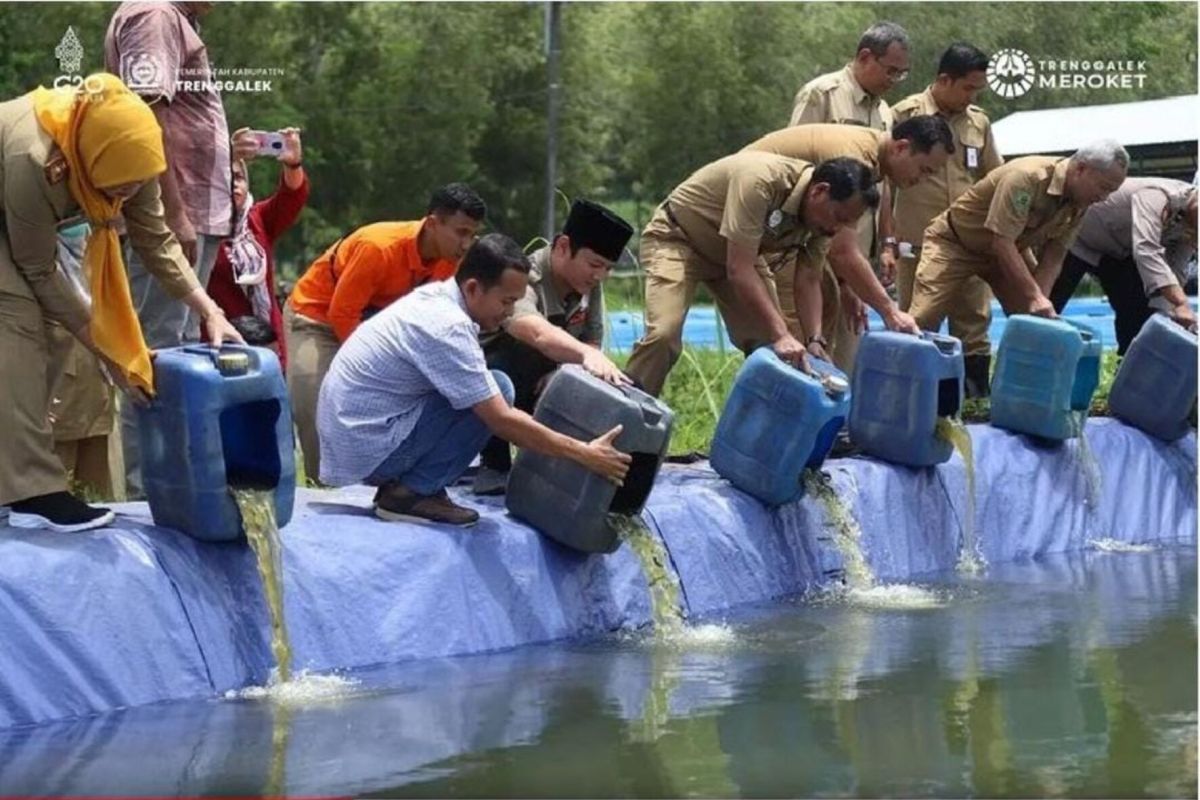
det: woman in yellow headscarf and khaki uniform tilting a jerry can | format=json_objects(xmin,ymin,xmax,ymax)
[{"xmin": 0, "ymin": 74, "xmax": 241, "ymax": 531}]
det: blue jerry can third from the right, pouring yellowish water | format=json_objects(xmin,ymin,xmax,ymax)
[{"xmin": 850, "ymin": 331, "xmax": 962, "ymax": 467}]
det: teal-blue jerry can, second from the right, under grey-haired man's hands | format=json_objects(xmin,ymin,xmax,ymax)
[{"xmin": 991, "ymin": 314, "xmax": 1102, "ymax": 441}]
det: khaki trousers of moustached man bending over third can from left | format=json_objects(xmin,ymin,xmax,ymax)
[{"xmin": 625, "ymin": 233, "xmax": 779, "ymax": 397}]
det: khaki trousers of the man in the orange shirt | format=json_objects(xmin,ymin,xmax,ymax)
[{"xmin": 283, "ymin": 303, "xmax": 341, "ymax": 481}]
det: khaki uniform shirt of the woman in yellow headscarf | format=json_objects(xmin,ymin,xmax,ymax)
[{"xmin": 0, "ymin": 96, "xmax": 199, "ymax": 330}]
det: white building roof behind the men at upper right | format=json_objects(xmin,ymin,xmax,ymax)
[{"xmin": 992, "ymin": 95, "xmax": 1200, "ymax": 158}]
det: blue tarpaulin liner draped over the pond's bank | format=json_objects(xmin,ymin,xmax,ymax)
[{"xmin": 0, "ymin": 420, "xmax": 1196, "ymax": 728}]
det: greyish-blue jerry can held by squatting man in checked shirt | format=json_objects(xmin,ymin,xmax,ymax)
[{"xmin": 505, "ymin": 365, "xmax": 674, "ymax": 553}]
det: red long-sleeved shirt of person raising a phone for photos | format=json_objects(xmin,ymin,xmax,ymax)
[{"xmin": 209, "ymin": 175, "xmax": 308, "ymax": 369}]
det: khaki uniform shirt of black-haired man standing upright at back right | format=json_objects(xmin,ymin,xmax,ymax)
[{"xmin": 892, "ymin": 89, "xmax": 1004, "ymax": 249}]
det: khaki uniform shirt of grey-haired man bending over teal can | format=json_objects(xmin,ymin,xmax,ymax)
[{"xmin": 926, "ymin": 156, "xmax": 1087, "ymax": 259}]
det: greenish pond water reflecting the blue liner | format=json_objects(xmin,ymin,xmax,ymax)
[{"xmin": 0, "ymin": 546, "xmax": 1196, "ymax": 798}]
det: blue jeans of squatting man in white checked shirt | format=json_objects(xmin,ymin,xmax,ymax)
[{"xmin": 364, "ymin": 369, "xmax": 514, "ymax": 494}]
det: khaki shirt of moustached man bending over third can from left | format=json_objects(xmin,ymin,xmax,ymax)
[{"xmin": 646, "ymin": 152, "xmax": 829, "ymax": 269}]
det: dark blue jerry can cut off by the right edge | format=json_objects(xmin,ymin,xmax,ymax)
[{"xmin": 1109, "ymin": 314, "xmax": 1196, "ymax": 441}]
